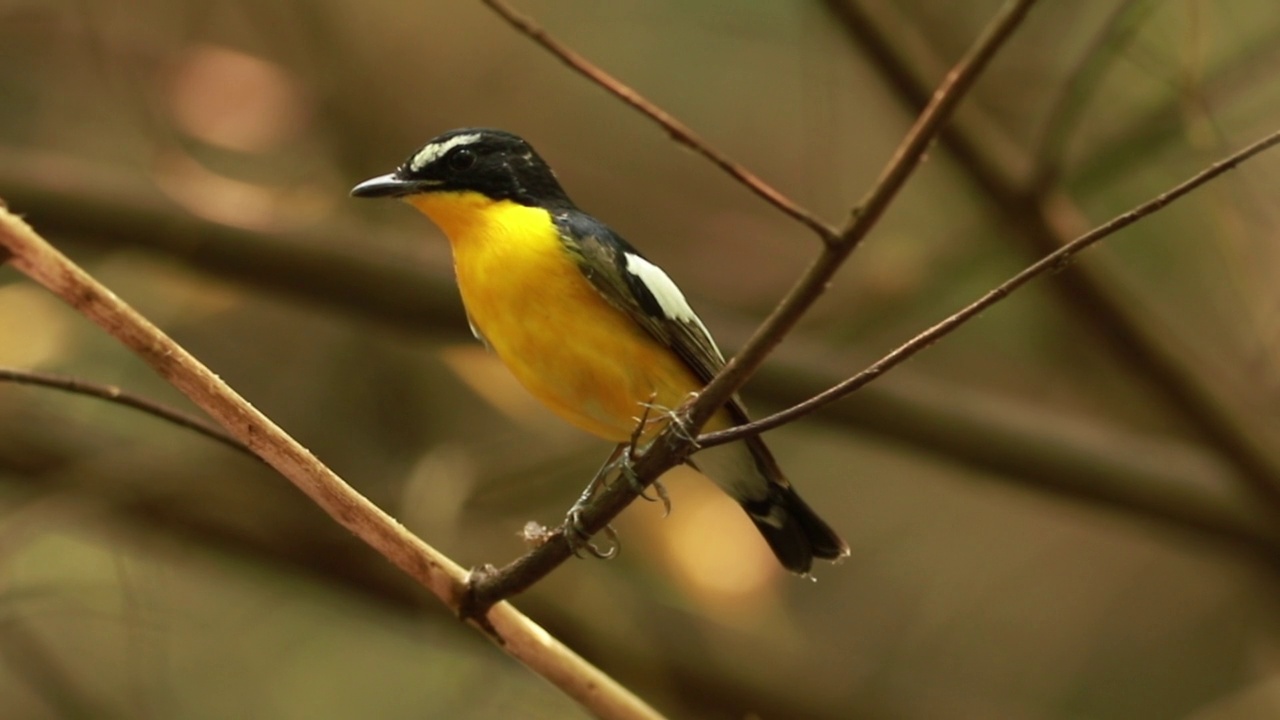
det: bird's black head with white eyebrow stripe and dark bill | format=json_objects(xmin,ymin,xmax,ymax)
[{"xmin": 351, "ymin": 128, "xmax": 572, "ymax": 208}]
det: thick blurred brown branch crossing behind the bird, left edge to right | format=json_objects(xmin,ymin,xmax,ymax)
[{"xmin": 0, "ymin": 149, "xmax": 1271, "ymax": 548}]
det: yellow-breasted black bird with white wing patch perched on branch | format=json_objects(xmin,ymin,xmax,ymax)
[{"xmin": 351, "ymin": 128, "xmax": 849, "ymax": 575}]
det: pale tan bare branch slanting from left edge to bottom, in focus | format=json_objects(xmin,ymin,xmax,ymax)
[{"xmin": 0, "ymin": 210, "xmax": 660, "ymax": 719}]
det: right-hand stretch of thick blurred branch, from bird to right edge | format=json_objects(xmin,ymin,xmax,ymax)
[{"xmin": 753, "ymin": 350, "xmax": 1280, "ymax": 548}]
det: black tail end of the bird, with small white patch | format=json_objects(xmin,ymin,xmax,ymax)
[{"xmin": 742, "ymin": 480, "xmax": 849, "ymax": 575}]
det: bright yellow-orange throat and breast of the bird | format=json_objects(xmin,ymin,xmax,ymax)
[{"xmin": 408, "ymin": 192, "xmax": 701, "ymax": 442}]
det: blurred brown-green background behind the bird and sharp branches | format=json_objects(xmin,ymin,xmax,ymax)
[{"xmin": 0, "ymin": 0, "xmax": 1280, "ymax": 720}]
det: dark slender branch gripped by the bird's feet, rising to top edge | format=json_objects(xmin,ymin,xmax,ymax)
[{"xmin": 467, "ymin": 0, "xmax": 1034, "ymax": 610}]
